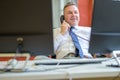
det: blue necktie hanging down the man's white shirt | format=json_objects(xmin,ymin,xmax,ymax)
[{"xmin": 69, "ymin": 27, "xmax": 84, "ymax": 58}]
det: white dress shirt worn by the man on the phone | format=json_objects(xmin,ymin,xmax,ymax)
[{"xmin": 54, "ymin": 26, "xmax": 92, "ymax": 59}]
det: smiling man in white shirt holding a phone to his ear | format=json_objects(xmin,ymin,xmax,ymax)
[{"xmin": 54, "ymin": 2, "xmax": 92, "ymax": 59}]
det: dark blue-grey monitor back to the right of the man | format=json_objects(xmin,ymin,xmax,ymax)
[{"xmin": 89, "ymin": 0, "xmax": 120, "ymax": 53}]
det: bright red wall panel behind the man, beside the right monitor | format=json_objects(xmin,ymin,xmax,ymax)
[{"xmin": 78, "ymin": 0, "xmax": 93, "ymax": 27}]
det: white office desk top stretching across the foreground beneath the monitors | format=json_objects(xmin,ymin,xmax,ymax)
[{"xmin": 0, "ymin": 61, "xmax": 120, "ymax": 80}]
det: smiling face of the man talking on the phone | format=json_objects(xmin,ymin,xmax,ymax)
[{"xmin": 64, "ymin": 5, "xmax": 80, "ymax": 26}]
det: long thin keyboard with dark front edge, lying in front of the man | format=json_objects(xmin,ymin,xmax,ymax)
[{"xmin": 34, "ymin": 58, "xmax": 108, "ymax": 65}]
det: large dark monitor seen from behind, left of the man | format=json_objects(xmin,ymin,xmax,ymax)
[{"xmin": 0, "ymin": 0, "xmax": 53, "ymax": 56}]
